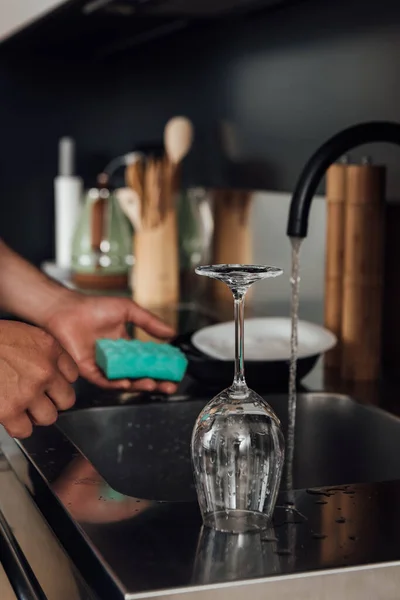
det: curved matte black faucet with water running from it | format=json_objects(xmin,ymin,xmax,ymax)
[{"xmin": 287, "ymin": 121, "xmax": 400, "ymax": 238}]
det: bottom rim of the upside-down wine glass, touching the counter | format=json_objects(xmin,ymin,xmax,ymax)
[{"xmin": 203, "ymin": 509, "xmax": 270, "ymax": 533}]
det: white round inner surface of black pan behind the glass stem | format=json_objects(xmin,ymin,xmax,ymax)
[{"xmin": 192, "ymin": 317, "xmax": 337, "ymax": 361}]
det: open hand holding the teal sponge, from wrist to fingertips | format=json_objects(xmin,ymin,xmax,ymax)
[{"xmin": 44, "ymin": 294, "xmax": 177, "ymax": 394}]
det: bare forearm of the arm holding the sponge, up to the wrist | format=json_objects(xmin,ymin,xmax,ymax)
[{"xmin": 0, "ymin": 240, "xmax": 75, "ymax": 326}]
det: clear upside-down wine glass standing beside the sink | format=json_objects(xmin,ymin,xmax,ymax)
[{"xmin": 191, "ymin": 265, "xmax": 284, "ymax": 533}]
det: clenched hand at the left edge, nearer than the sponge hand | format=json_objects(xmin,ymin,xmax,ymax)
[{"xmin": 0, "ymin": 321, "xmax": 78, "ymax": 438}]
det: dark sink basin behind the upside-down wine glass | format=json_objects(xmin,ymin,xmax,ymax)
[{"xmin": 58, "ymin": 393, "xmax": 400, "ymax": 502}]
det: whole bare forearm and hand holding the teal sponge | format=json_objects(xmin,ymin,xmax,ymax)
[{"xmin": 0, "ymin": 240, "xmax": 176, "ymax": 398}]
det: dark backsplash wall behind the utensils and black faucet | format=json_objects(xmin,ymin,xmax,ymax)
[{"xmin": 0, "ymin": 0, "xmax": 400, "ymax": 262}]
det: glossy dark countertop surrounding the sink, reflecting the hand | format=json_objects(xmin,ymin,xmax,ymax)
[{"xmin": 0, "ymin": 302, "xmax": 400, "ymax": 600}]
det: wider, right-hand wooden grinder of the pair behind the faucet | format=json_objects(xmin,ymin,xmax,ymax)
[{"xmin": 341, "ymin": 164, "xmax": 386, "ymax": 381}]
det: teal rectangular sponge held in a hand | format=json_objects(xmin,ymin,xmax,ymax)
[{"xmin": 96, "ymin": 340, "xmax": 188, "ymax": 382}]
